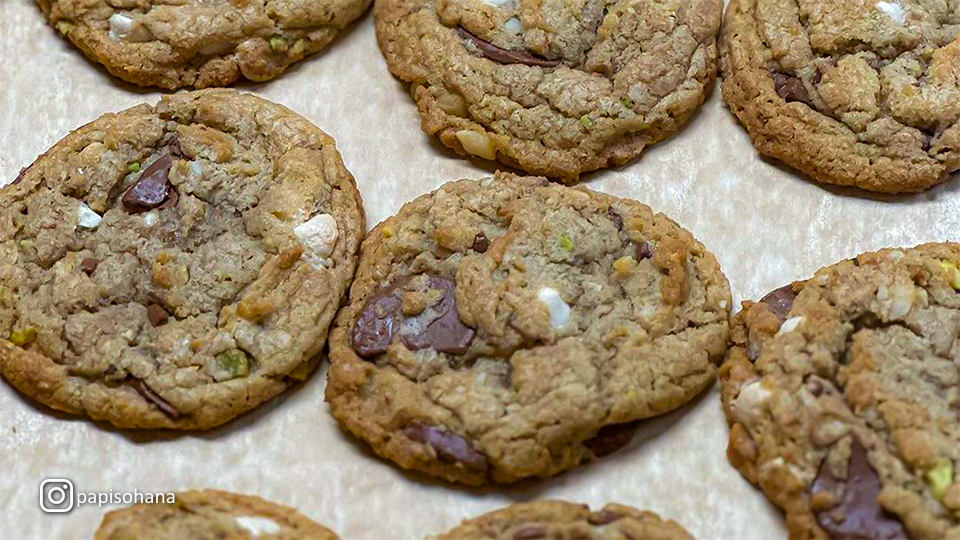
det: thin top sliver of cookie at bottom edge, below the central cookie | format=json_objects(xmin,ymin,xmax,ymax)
[{"xmin": 430, "ymin": 501, "xmax": 693, "ymax": 540}]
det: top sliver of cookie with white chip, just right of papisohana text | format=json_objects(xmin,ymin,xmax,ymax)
[{"xmin": 93, "ymin": 490, "xmax": 339, "ymax": 540}]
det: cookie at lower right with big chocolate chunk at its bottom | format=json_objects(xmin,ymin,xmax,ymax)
[{"xmin": 720, "ymin": 244, "xmax": 960, "ymax": 540}]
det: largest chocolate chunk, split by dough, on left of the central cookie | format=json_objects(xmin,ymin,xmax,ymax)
[{"xmin": 351, "ymin": 275, "xmax": 476, "ymax": 357}]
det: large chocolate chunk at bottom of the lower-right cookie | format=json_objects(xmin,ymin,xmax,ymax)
[{"xmin": 811, "ymin": 437, "xmax": 909, "ymax": 540}]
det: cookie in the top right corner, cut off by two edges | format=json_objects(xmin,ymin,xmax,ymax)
[{"xmin": 722, "ymin": 0, "xmax": 960, "ymax": 193}]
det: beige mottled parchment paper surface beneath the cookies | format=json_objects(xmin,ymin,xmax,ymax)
[{"xmin": 0, "ymin": 0, "xmax": 960, "ymax": 540}]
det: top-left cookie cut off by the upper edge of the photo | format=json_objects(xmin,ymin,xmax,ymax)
[{"xmin": 37, "ymin": 0, "xmax": 371, "ymax": 89}]
